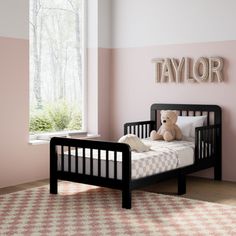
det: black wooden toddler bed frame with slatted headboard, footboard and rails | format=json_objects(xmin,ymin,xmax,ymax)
[{"xmin": 50, "ymin": 104, "xmax": 222, "ymax": 209}]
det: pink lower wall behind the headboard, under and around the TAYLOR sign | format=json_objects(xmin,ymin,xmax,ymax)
[{"xmin": 109, "ymin": 41, "xmax": 236, "ymax": 181}]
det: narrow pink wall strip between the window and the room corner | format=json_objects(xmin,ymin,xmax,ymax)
[{"xmin": 87, "ymin": 48, "xmax": 111, "ymax": 140}]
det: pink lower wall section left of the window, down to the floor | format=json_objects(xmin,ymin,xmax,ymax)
[{"xmin": 0, "ymin": 37, "xmax": 49, "ymax": 188}]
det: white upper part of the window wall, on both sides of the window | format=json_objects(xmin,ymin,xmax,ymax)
[{"xmin": 0, "ymin": 0, "xmax": 112, "ymax": 48}]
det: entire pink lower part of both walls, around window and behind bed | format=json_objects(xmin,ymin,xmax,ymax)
[{"xmin": 0, "ymin": 37, "xmax": 236, "ymax": 187}]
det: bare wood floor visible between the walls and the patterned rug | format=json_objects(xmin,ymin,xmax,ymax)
[{"xmin": 0, "ymin": 177, "xmax": 236, "ymax": 206}]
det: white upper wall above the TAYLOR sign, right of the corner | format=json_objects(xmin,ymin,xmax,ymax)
[{"xmin": 111, "ymin": 0, "xmax": 236, "ymax": 48}]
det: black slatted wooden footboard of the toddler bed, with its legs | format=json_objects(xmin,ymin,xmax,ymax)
[{"xmin": 50, "ymin": 137, "xmax": 131, "ymax": 209}]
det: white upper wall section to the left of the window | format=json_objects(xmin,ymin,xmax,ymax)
[{"xmin": 0, "ymin": 0, "xmax": 29, "ymax": 39}]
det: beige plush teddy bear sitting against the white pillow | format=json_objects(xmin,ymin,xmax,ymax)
[{"xmin": 150, "ymin": 110, "xmax": 182, "ymax": 142}]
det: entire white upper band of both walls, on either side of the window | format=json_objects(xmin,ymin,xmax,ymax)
[{"xmin": 0, "ymin": 0, "xmax": 236, "ymax": 48}]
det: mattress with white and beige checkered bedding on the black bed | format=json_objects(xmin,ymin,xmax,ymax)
[{"xmin": 58, "ymin": 139, "xmax": 194, "ymax": 179}]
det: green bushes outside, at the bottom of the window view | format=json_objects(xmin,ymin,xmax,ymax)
[{"xmin": 30, "ymin": 101, "xmax": 82, "ymax": 134}]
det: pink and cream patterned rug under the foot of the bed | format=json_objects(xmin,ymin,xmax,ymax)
[{"xmin": 0, "ymin": 182, "xmax": 236, "ymax": 236}]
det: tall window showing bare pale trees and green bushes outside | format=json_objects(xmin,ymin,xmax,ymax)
[{"xmin": 30, "ymin": 0, "xmax": 85, "ymax": 139}]
